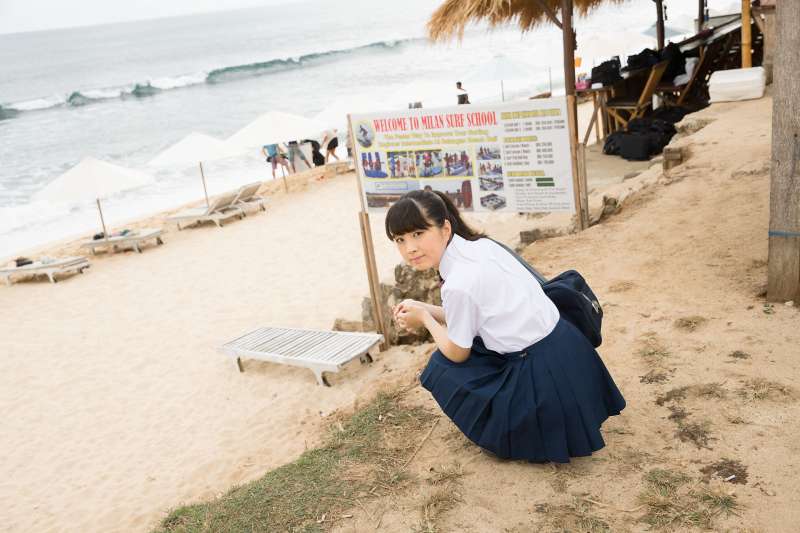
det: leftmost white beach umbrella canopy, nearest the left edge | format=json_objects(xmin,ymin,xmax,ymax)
[{"xmin": 35, "ymin": 157, "xmax": 155, "ymax": 203}]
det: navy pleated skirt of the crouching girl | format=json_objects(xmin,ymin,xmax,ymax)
[{"xmin": 420, "ymin": 319, "xmax": 625, "ymax": 463}]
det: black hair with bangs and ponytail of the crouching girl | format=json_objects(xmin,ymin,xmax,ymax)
[{"xmin": 386, "ymin": 191, "xmax": 486, "ymax": 241}]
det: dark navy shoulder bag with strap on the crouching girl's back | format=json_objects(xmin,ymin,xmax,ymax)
[{"xmin": 490, "ymin": 239, "xmax": 603, "ymax": 348}]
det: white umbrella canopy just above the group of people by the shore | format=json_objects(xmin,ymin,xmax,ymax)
[{"xmin": 227, "ymin": 111, "xmax": 327, "ymax": 148}]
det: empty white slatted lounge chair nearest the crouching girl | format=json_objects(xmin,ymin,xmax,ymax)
[{"xmin": 220, "ymin": 328, "xmax": 383, "ymax": 387}]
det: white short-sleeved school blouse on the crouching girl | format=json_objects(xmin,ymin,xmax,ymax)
[{"xmin": 439, "ymin": 235, "xmax": 559, "ymax": 353}]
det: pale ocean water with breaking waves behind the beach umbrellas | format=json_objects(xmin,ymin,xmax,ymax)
[{"xmin": 0, "ymin": 0, "xmax": 694, "ymax": 258}]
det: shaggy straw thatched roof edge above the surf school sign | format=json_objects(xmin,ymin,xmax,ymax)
[{"xmin": 428, "ymin": 0, "xmax": 628, "ymax": 41}]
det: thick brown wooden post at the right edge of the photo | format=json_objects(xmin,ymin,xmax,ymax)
[{"xmin": 767, "ymin": 1, "xmax": 800, "ymax": 304}]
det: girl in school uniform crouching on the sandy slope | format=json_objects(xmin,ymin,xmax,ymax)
[{"xmin": 385, "ymin": 190, "xmax": 625, "ymax": 463}]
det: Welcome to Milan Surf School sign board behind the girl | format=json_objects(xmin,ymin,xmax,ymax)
[{"xmin": 350, "ymin": 97, "xmax": 575, "ymax": 213}]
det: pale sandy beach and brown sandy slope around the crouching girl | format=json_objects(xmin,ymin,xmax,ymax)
[{"xmin": 0, "ymin": 92, "xmax": 800, "ymax": 532}]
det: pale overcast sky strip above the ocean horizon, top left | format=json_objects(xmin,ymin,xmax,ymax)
[{"xmin": 0, "ymin": 0, "xmax": 294, "ymax": 33}]
